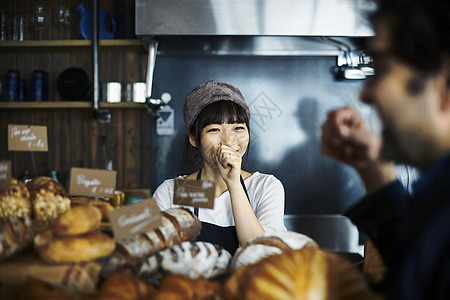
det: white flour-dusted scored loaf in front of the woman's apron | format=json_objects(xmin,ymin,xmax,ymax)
[{"xmin": 138, "ymin": 242, "xmax": 231, "ymax": 282}]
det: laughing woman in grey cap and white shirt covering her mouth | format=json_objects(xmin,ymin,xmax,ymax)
[{"xmin": 153, "ymin": 81, "xmax": 286, "ymax": 254}]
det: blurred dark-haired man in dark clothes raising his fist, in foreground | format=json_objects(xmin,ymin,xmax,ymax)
[{"xmin": 321, "ymin": 0, "xmax": 450, "ymax": 299}]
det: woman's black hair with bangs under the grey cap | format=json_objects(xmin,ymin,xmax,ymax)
[{"xmin": 185, "ymin": 101, "xmax": 250, "ymax": 168}]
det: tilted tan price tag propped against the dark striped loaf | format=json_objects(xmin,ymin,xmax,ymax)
[{"xmin": 109, "ymin": 198, "xmax": 162, "ymax": 240}]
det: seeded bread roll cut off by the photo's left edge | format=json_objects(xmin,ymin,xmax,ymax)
[{"xmin": 0, "ymin": 179, "xmax": 31, "ymax": 218}]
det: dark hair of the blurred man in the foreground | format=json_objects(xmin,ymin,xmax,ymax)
[{"xmin": 371, "ymin": 0, "xmax": 450, "ymax": 75}]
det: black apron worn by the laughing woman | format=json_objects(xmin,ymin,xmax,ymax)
[{"xmin": 194, "ymin": 169, "xmax": 250, "ymax": 255}]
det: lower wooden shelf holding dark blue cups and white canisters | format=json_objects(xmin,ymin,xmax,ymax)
[{"xmin": 0, "ymin": 101, "xmax": 145, "ymax": 109}]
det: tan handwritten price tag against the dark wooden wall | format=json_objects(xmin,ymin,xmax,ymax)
[{"xmin": 8, "ymin": 124, "xmax": 48, "ymax": 152}]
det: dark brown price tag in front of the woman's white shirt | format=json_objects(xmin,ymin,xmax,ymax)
[{"xmin": 173, "ymin": 179, "xmax": 215, "ymax": 209}]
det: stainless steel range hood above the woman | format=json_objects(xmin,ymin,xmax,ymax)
[{"xmin": 136, "ymin": 0, "xmax": 373, "ymax": 55}]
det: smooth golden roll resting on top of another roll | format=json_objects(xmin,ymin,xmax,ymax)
[{"xmin": 53, "ymin": 205, "xmax": 102, "ymax": 237}]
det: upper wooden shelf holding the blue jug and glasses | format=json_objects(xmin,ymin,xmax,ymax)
[{"xmin": 0, "ymin": 39, "xmax": 144, "ymax": 50}]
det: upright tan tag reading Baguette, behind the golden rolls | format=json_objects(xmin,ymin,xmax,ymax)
[{"xmin": 69, "ymin": 168, "xmax": 116, "ymax": 197}]
